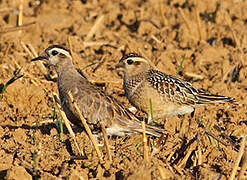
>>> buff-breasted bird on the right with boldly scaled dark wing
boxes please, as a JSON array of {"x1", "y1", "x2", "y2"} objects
[{"x1": 115, "y1": 53, "x2": 235, "y2": 123}]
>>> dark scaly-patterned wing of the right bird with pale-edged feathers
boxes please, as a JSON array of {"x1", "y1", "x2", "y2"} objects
[{"x1": 148, "y1": 70, "x2": 235, "y2": 105}]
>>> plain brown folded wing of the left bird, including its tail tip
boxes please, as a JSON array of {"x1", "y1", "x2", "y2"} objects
[{"x1": 66, "y1": 80, "x2": 164, "y2": 136}]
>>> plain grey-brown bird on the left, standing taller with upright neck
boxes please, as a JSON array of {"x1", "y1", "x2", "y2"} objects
[{"x1": 31, "y1": 45, "x2": 164, "y2": 137}]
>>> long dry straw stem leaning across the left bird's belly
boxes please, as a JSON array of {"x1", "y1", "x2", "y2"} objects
[{"x1": 68, "y1": 92, "x2": 102, "y2": 160}]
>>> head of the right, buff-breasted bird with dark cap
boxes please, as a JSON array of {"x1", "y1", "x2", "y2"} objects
[{"x1": 116, "y1": 53, "x2": 150, "y2": 76}]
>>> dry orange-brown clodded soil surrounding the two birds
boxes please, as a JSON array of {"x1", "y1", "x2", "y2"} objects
[{"x1": 0, "y1": 0, "x2": 247, "y2": 179}]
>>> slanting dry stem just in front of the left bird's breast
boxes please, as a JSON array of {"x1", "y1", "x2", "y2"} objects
[{"x1": 53, "y1": 93, "x2": 84, "y2": 156}]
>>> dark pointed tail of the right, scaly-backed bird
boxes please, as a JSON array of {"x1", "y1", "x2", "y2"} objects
[{"x1": 197, "y1": 93, "x2": 237, "y2": 104}]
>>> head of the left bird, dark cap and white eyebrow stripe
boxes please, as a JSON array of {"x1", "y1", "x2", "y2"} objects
[{"x1": 31, "y1": 45, "x2": 72, "y2": 67}]
